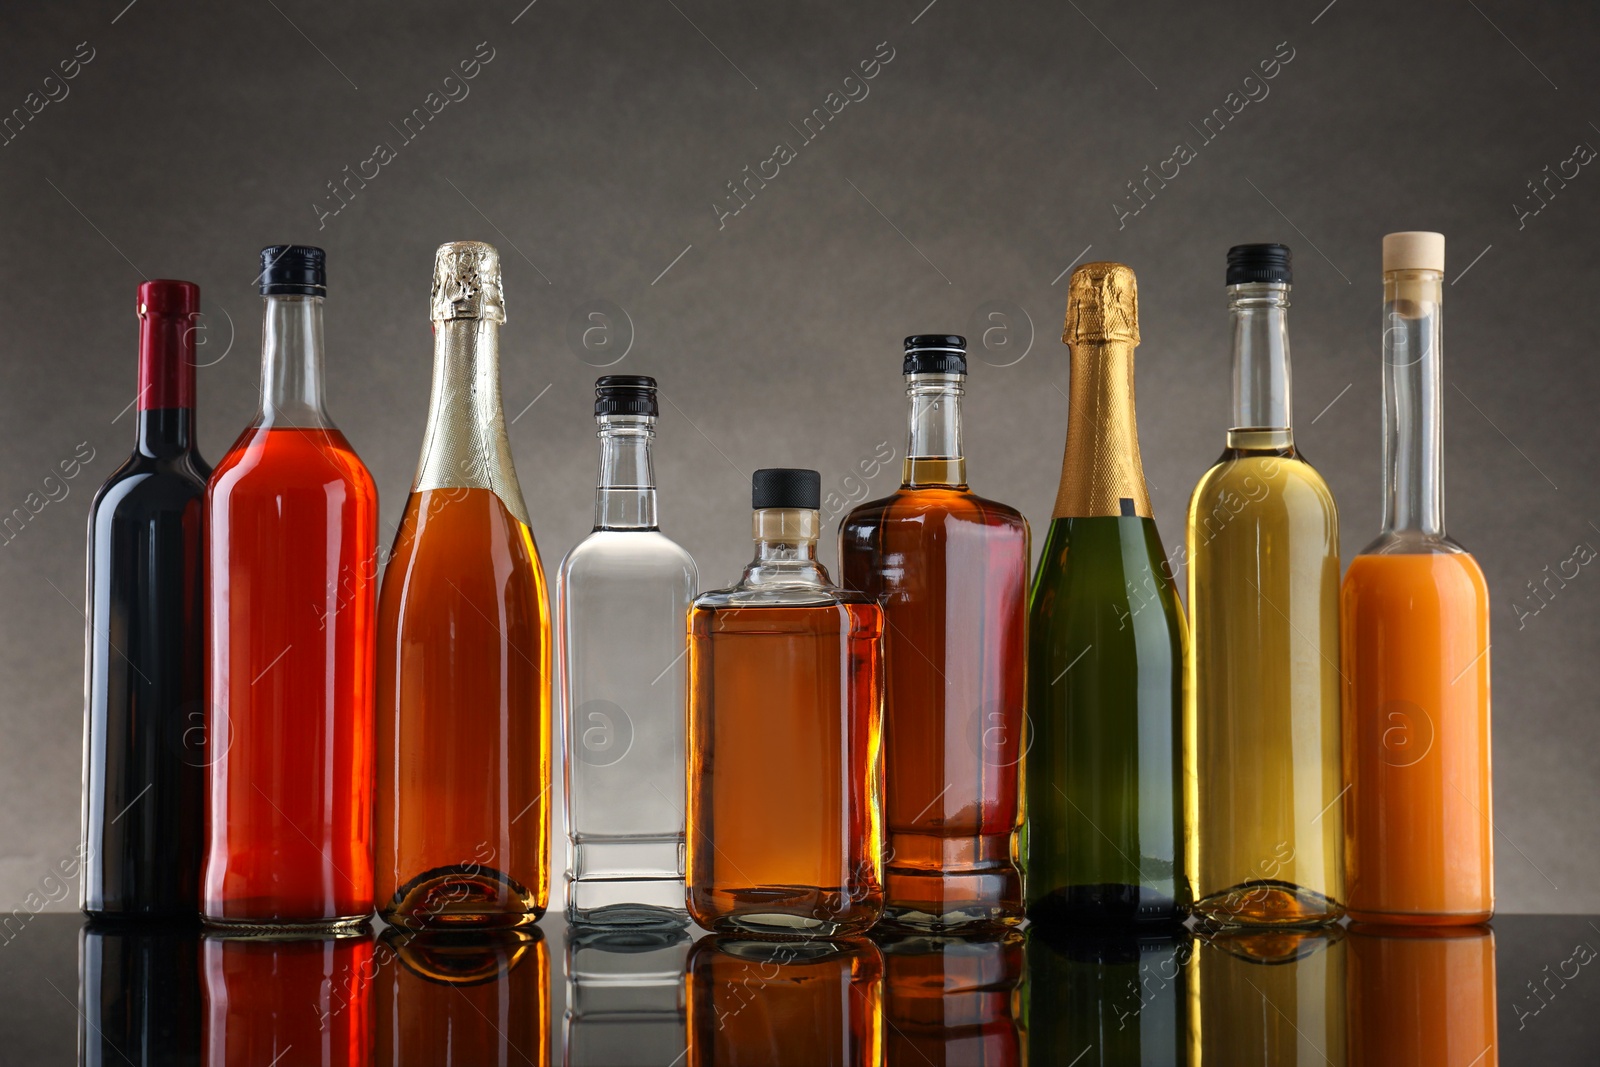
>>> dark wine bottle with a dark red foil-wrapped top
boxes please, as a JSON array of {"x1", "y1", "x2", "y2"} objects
[{"x1": 80, "y1": 282, "x2": 211, "y2": 921}]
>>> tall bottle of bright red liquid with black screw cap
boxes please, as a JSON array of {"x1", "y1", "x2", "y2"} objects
[{"x1": 200, "y1": 245, "x2": 378, "y2": 926}]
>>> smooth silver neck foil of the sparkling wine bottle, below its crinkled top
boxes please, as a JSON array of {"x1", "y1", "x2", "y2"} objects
[{"x1": 413, "y1": 318, "x2": 530, "y2": 526}]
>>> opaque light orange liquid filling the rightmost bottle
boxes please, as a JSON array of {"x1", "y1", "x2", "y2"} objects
[{"x1": 1341, "y1": 553, "x2": 1494, "y2": 925}]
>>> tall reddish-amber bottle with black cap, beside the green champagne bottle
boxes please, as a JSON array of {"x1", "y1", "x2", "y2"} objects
[{"x1": 838, "y1": 334, "x2": 1029, "y2": 929}]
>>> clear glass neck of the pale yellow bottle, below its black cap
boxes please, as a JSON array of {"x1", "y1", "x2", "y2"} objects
[{"x1": 1227, "y1": 282, "x2": 1294, "y2": 448}]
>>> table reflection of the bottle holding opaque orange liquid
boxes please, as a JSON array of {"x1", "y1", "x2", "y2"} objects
[{"x1": 1349, "y1": 926, "x2": 1499, "y2": 1067}]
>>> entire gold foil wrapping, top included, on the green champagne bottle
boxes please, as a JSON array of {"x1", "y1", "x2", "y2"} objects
[{"x1": 1051, "y1": 262, "x2": 1150, "y2": 518}]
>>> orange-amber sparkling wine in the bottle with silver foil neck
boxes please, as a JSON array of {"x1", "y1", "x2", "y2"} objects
[{"x1": 378, "y1": 490, "x2": 550, "y2": 928}]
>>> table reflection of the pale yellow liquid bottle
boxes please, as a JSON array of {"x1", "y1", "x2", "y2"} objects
[{"x1": 1190, "y1": 926, "x2": 1347, "y2": 1067}]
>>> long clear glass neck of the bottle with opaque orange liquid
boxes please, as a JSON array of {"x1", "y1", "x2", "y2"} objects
[{"x1": 1384, "y1": 270, "x2": 1445, "y2": 537}]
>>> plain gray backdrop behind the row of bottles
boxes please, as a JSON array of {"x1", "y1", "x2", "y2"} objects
[{"x1": 0, "y1": 0, "x2": 1600, "y2": 912}]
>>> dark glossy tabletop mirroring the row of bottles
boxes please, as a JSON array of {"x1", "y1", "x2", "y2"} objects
[{"x1": 0, "y1": 913, "x2": 1600, "y2": 1067}]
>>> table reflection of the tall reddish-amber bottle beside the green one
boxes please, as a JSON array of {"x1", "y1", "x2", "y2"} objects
[{"x1": 878, "y1": 929, "x2": 1022, "y2": 1067}]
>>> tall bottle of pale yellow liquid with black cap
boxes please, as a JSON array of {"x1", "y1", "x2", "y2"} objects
[{"x1": 1186, "y1": 245, "x2": 1344, "y2": 926}]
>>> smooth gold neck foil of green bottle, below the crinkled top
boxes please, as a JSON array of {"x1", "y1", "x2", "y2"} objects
[{"x1": 1051, "y1": 339, "x2": 1150, "y2": 518}]
